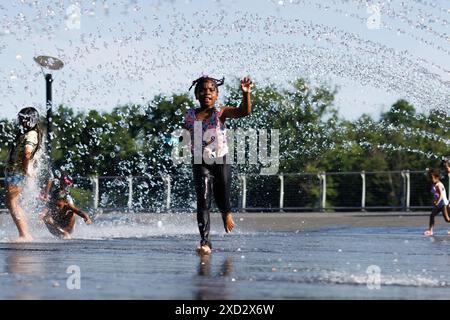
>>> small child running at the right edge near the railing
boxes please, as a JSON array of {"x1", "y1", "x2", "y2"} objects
[{"x1": 424, "y1": 169, "x2": 450, "y2": 236}]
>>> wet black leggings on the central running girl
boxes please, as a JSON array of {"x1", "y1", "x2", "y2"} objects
[{"x1": 193, "y1": 156, "x2": 231, "y2": 248}]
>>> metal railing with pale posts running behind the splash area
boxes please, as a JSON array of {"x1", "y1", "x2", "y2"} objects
[{"x1": 0, "y1": 170, "x2": 450, "y2": 212}]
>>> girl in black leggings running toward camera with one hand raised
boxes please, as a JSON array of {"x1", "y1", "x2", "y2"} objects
[{"x1": 185, "y1": 76, "x2": 252, "y2": 254}]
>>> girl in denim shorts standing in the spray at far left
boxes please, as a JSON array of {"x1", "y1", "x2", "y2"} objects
[{"x1": 5, "y1": 107, "x2": 42, "y2": 242}]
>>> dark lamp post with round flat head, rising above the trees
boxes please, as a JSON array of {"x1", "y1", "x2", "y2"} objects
[{"x1": 34, "y1": 56, "x2": 64, "y2": 163}]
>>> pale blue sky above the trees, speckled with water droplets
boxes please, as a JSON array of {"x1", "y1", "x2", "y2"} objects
[{"x1": 0, "y1": 0, "x2": 450, "y2": 120}]
